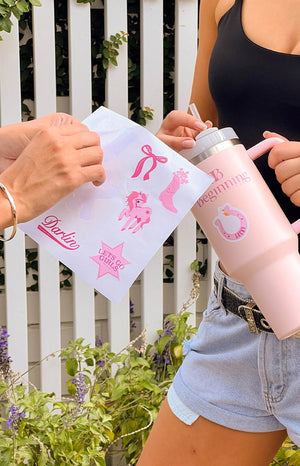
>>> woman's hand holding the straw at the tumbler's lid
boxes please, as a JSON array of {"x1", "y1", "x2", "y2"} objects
[{"x1": 156, "y1": 110, "x2": 212, "y2": 152}]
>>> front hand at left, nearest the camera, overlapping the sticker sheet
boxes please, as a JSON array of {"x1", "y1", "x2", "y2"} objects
[{"x1": 0, "y1": 120, "x2": 105, "y2": 222}]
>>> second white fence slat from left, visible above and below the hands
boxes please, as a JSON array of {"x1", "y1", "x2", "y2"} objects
[{"x1": 32, "y1": 0, "x2": 61, "y2": 398}]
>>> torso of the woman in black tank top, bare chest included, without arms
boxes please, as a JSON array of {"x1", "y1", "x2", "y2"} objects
[{"x1": 209, "y1": 0, "x2": 300, "y2": 237}]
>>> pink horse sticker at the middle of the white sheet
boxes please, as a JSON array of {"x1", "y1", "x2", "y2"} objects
[{"x1": 118, "y1": 191, "x2": 152, "y2": 233}]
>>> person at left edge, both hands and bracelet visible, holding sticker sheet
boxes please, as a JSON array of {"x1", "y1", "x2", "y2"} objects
[{"x1": 0, "y1": 113, "x2": 105, "y2": 240}]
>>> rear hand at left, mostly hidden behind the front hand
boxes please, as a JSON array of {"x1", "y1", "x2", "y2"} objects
[{"x1": 0, "y1": 113, "x2": 81, "y2": 173}]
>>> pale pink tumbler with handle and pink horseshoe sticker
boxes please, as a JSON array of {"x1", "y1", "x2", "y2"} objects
[{"x1": 181, "y1": 128, "x2": 300, "y2": 339}]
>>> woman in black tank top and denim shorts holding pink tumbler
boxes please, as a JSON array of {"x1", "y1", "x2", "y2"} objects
[{"x1": 138, "y1": 0, "x2": 300, "y2": 466}]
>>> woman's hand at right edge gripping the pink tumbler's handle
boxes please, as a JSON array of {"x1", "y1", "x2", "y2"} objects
[{"x1": 264, "y1": 131, "x2": 300, "y2": 207}]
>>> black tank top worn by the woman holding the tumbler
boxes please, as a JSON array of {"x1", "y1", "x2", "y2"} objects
[{"x1": 209, "y1": 0, "x2": 300, "y2": 248}]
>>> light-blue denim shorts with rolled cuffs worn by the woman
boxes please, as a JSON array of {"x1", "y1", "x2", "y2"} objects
[{"x1": 168, "y1": 265, "x2": 300, "y2": 447}]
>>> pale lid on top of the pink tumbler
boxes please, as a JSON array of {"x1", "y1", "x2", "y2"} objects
[{"x1": 180, "y1": 127, "x2": 238, "y2": 160}]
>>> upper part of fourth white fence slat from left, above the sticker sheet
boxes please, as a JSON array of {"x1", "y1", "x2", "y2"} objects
[{"x1": 104, "y1": 0, "x2": 128, "y2": 117}]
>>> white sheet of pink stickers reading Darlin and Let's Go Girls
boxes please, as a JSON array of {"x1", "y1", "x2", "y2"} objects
[{"x1": 19, "y1": 107, "x2": 213, "y2": 303}]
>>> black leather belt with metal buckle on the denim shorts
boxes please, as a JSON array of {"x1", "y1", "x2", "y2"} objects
[{"x1": 214, "y1": 279, "x2": 274, "y2": 334}]
